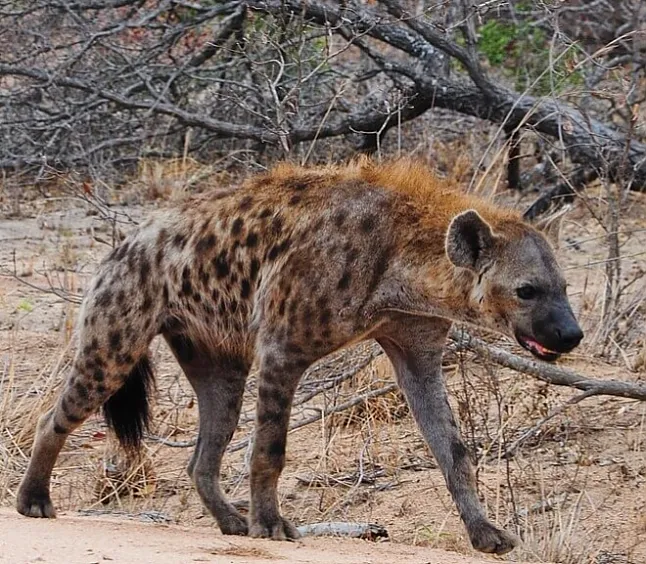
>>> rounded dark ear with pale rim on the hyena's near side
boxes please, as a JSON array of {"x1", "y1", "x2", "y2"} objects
[{"x1": 446, "y1": 210, "x2": 495, "y2": 271}]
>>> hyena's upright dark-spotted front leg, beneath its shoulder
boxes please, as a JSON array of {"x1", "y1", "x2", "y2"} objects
[{"x1": 249, "y1": 346, "x2": 310, "y2": 540}]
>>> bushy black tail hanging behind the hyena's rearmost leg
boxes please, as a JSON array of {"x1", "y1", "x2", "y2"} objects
[{"x1": 103, "y1": 355, "x2": 155, "y2": 452}]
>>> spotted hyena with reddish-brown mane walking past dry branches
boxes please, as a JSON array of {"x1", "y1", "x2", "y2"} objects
[{"x1": 17, "y1": 161, "x2": 583, "y2": 554}]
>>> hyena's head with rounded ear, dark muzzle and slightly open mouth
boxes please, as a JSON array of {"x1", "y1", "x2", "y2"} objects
[{"x1": 446, "y1": 210, "x2": 583, "y2": 360}]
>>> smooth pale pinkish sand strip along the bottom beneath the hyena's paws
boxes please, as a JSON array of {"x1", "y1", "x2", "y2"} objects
[{"x1": 0, "y1": 509, "x2": 512, "y2": 564}]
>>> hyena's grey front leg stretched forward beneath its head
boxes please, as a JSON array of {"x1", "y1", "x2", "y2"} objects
[{"x1": 378, "y1": 319, "x2": 516, "y2": 554}]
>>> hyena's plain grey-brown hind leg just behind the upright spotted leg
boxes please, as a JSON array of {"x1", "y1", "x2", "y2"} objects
[{"x1": 165, "y1": 335, "x2": 249, "y2": 535}]
